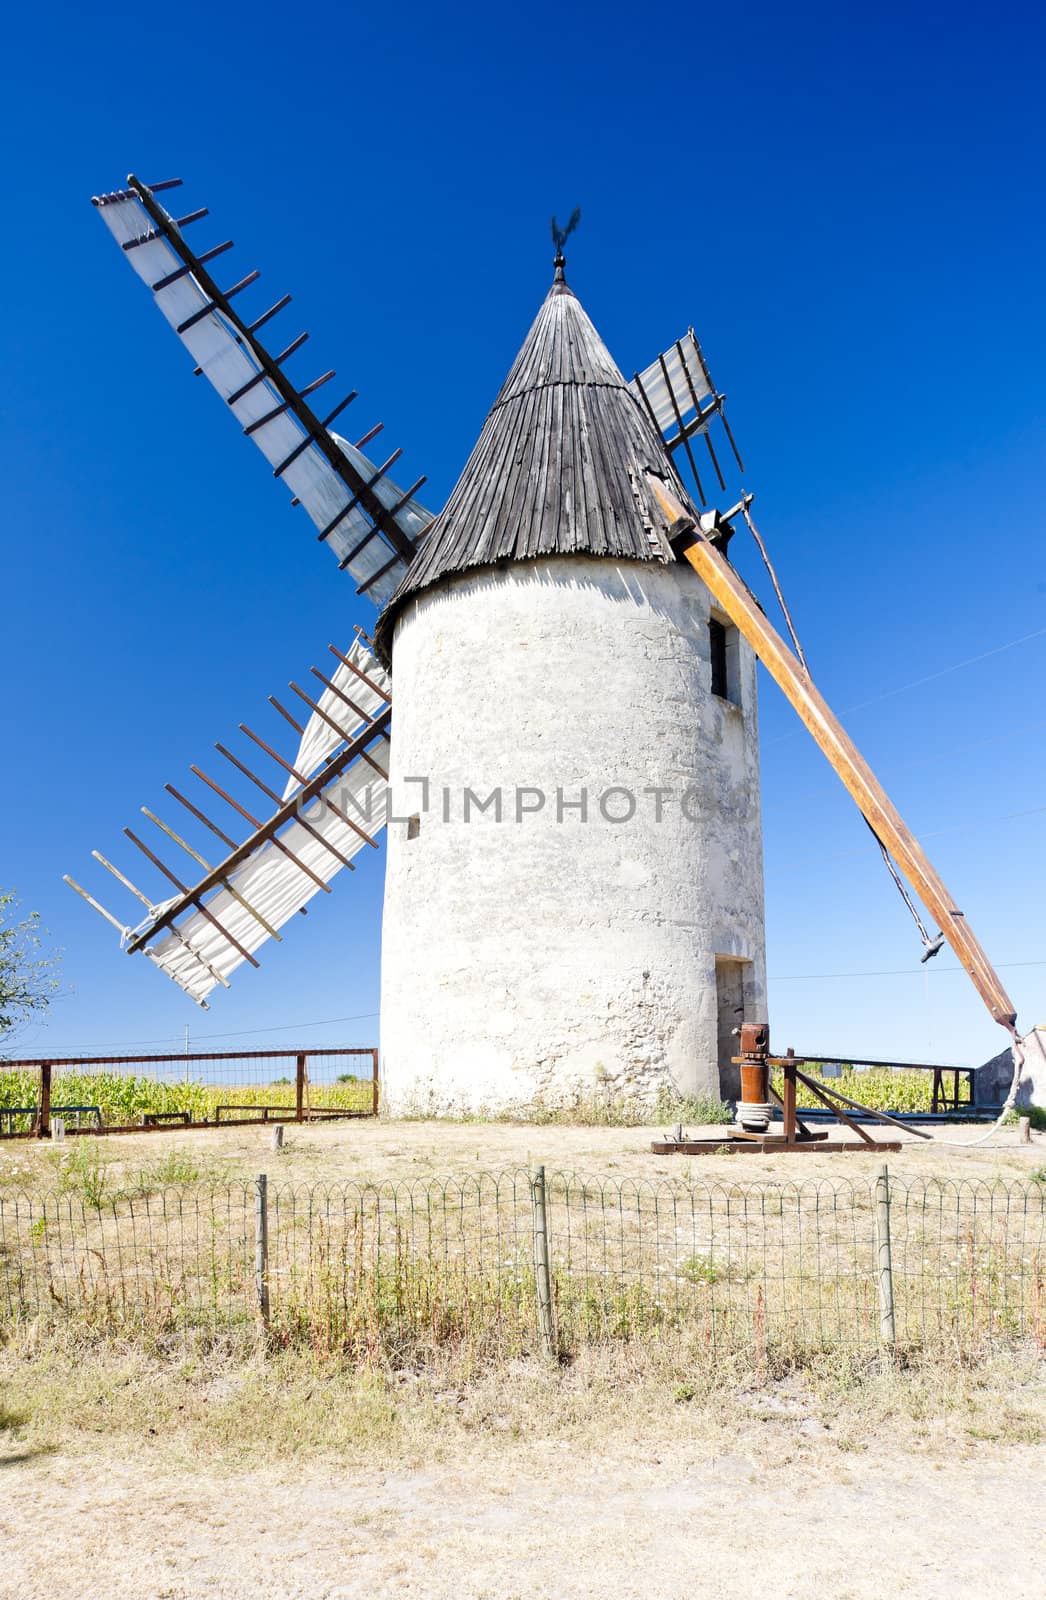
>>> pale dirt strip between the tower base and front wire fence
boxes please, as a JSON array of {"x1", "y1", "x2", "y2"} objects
[{"x1": 0, "y1": 1118, "x2": 1046, "y2": 1194}]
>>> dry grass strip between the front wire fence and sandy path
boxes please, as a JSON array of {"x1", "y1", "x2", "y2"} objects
[{"x1": 0, "y1": 1336, "x2": 1046, "y2": 1474}]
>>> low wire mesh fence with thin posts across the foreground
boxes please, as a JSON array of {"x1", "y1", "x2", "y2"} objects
[{"x1": 0, "y1": 1170, "x2": 1046, "y2": 1362}]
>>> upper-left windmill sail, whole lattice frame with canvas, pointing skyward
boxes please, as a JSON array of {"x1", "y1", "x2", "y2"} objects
[{"x1": 94, "y1": 176, "x2": 432, "y2": 606}]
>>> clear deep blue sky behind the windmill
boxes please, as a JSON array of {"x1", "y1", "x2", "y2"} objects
[{"x1": 0, "y1": 3, "x2": 1046, "y2": 1061}]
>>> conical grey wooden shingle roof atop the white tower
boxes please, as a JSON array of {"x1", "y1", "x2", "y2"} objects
[{"x1": 376, "y1": 259, "x2": 675, "y2": 658}]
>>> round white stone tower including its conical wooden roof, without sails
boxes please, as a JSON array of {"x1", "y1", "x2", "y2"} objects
[{"x1": 377, "y1": 258, "x2": 766, "y2": 1114}]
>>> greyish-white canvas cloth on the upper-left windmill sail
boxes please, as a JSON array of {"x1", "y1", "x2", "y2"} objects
[{"x1": 99, "y1": 195, "x2": 432, "y2": 605}]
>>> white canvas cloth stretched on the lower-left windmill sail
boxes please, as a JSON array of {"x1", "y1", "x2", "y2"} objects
[{"x1": 131, "y1": 640, "x2": 390, "y2": 1005}]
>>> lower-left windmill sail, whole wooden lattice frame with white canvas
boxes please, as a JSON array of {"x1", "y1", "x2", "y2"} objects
[{"x1": 66, "y1": 638, "x2": 392, "y2": 1005}]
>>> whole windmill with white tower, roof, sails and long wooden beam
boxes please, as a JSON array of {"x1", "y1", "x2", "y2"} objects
[{"x1": 67, "y1": 178, "x2": 1014, "y2": 1110}]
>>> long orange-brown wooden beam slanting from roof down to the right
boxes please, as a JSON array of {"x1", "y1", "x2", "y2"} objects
[{"x1": 646, "y1": 472, "x2": 1017, "y2": 1032}]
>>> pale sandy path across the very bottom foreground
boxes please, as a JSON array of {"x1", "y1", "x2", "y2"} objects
[{"x1": 0, "y1": 1440, "x2": 1046, "y2": 1600}]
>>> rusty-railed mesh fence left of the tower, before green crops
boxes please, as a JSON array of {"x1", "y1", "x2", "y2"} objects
[{"x1": 0, "y1": 1045, "x2": 377, "y2": 1138}]
